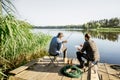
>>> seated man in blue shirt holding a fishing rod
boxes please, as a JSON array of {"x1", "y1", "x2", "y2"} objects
[{"x1": 49, "y1": 32, "x2": 67, "y2": 56}]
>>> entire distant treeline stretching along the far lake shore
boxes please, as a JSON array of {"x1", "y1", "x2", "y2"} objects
[{"x1": 33, "y1": 17, "x2": 120, "y2": 29}]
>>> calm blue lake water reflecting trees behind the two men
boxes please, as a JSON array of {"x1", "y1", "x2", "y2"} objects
[{"x1": 32, "y1": 29, "x2": 120, "y2": 64}]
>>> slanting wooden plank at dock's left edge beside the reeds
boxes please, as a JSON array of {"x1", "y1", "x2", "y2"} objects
[{"x1": 9, "y1": 60, "x2": 36, "y2": 74}]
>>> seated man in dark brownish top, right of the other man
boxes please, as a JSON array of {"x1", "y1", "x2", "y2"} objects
[{"x1": 76, "y1": 34, "x2": 100, "y2": 68}]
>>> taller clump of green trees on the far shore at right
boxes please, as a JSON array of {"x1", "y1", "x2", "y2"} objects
[{"x1": 83, "y1": 18, "x2": 120, "y2": 29}]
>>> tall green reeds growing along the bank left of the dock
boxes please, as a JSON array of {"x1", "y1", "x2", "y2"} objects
[{"x1": 0, "y1": 15, "x2": 51, "y2": 80}]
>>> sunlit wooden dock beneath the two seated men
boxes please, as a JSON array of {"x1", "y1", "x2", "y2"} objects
[{"x1": 9, "y1": 56, "x2": 120, "y2": 80}]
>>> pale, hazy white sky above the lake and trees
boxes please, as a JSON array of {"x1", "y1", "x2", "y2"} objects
[{"x1": 13, "y1": 0, "x2": 120, "y2": 26}]
